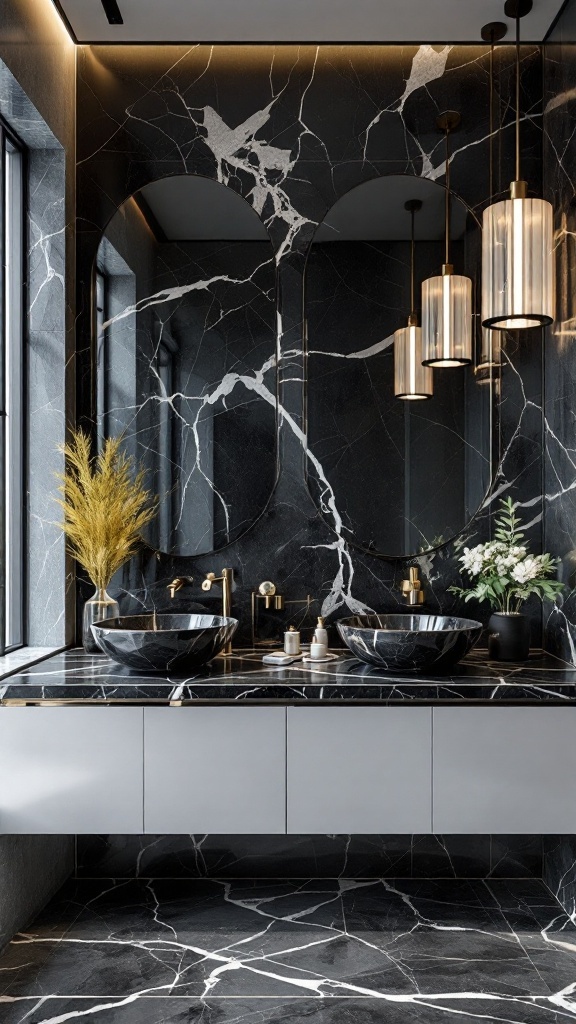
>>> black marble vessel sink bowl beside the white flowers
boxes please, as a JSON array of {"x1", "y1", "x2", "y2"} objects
[{"x1": 336, "y1": 613, "x2": 483, "y2": 673}]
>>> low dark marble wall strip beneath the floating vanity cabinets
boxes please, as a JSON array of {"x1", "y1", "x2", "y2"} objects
[{"x1": 76, "y1": 835, "x2": 541, "y2": 879}]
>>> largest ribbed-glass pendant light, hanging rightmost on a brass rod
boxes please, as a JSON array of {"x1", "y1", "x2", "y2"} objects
[{"x1": 482, "y1": 0, "x2": 554, "y2": 331}]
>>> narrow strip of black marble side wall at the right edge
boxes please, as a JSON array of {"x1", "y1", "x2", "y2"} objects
[{"x1": 543, "y1": 0, "x2": 576, "y2": 663}]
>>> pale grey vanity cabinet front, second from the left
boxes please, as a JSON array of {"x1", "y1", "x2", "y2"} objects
[{"x1": 145, "y1": 707, "x2": 286, "y2": 835}]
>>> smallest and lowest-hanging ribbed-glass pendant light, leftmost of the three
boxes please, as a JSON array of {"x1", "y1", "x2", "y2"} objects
[{"x1": 394, "y1": 199, "x2": 434, "y2": 401}]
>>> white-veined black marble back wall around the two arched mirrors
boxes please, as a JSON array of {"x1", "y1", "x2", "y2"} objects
[{"x1": 77, "y1": 45, "x2": 542, "y2": 642}]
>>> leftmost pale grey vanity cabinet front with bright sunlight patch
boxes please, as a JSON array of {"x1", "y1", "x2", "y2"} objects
[{"x1": 0, "y1": 707, "x2": 143, "y2": 835}]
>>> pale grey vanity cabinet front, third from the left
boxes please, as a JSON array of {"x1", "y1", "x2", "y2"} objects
[{"x1": 287, "y1": 706, "x2": 431, "y2": 834}]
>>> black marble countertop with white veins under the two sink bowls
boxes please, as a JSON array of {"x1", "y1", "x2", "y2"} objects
[{"x1": 0, "y1": 648, "x2": 576, "y2": 707}]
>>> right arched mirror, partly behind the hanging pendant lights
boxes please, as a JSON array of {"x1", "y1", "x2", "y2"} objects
[{"x1": 304, "y1": 175, "x2": 498, "y2": 557}]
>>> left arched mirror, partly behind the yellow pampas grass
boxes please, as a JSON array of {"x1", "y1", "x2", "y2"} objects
[{"x1": 95, "y1": 175, "x2": 277, "y2": 555}]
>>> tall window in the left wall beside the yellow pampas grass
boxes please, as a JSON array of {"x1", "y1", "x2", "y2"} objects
[{"x1": 0, "y1": 122, "x2": 26, "y2": 654}]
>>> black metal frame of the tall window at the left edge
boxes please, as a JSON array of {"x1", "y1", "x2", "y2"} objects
[{"x1": 0, "y1": 117, "x2": 29, "y2": 655}]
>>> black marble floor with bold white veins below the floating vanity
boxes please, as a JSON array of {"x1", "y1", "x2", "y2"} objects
[{"x1": 0, "y1": 879, "x2": 576, "y2": 1024}]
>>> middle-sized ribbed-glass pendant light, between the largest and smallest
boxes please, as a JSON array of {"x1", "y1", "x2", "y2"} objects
[{"x1": 422, "y1": 111, "x2": 472, "y2": 367}]
